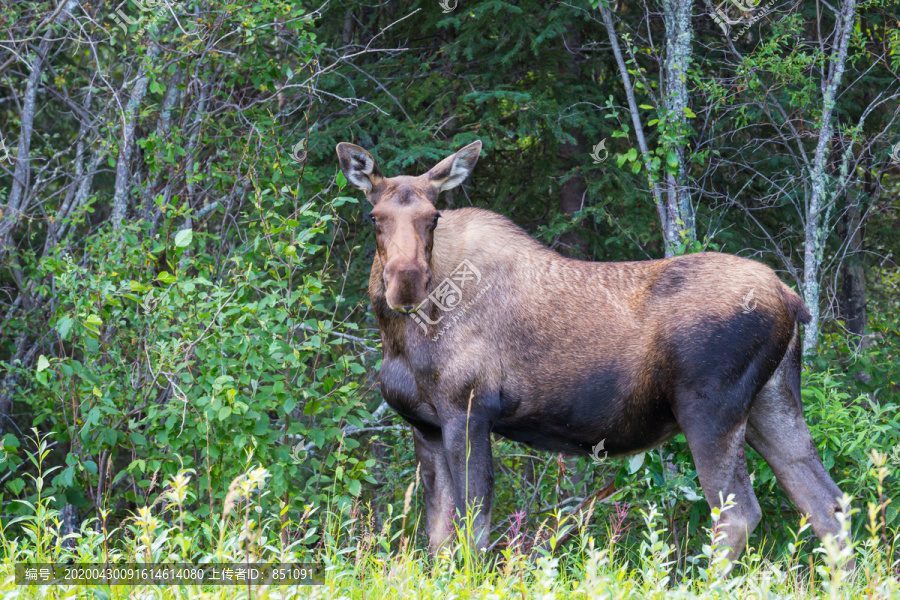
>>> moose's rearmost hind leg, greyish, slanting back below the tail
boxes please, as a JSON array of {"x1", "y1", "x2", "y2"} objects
[{"x1": 747, "y1": 351, "x2": 842, "y2": 539}]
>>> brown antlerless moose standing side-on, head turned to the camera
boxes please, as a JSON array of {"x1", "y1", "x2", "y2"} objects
[{"x1": 337, "y1": 141, "x2": 842, "y2": 560}]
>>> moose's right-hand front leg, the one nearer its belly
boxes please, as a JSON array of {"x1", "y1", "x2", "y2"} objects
[{"x1": 442, "y1": 413, "x2": 494, "y2": 550}]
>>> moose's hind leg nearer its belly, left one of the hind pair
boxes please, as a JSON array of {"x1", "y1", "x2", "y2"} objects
[{"x1": 677, "y1": 399, "x2": 762, "y2": 571}]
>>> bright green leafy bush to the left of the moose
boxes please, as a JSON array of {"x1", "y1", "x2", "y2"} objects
[{"x1": 0, "y1": 189, "x2": 375, "y2": 518}]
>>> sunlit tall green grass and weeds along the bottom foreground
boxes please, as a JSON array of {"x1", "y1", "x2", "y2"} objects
[{"x1": 0, "y1": 438, "x2": 900, "y2": 600}]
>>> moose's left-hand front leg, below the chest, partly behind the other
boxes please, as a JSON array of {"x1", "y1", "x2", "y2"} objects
[{"x1": 413, "y1": 427, "x2": 453, "y2": 556}]
